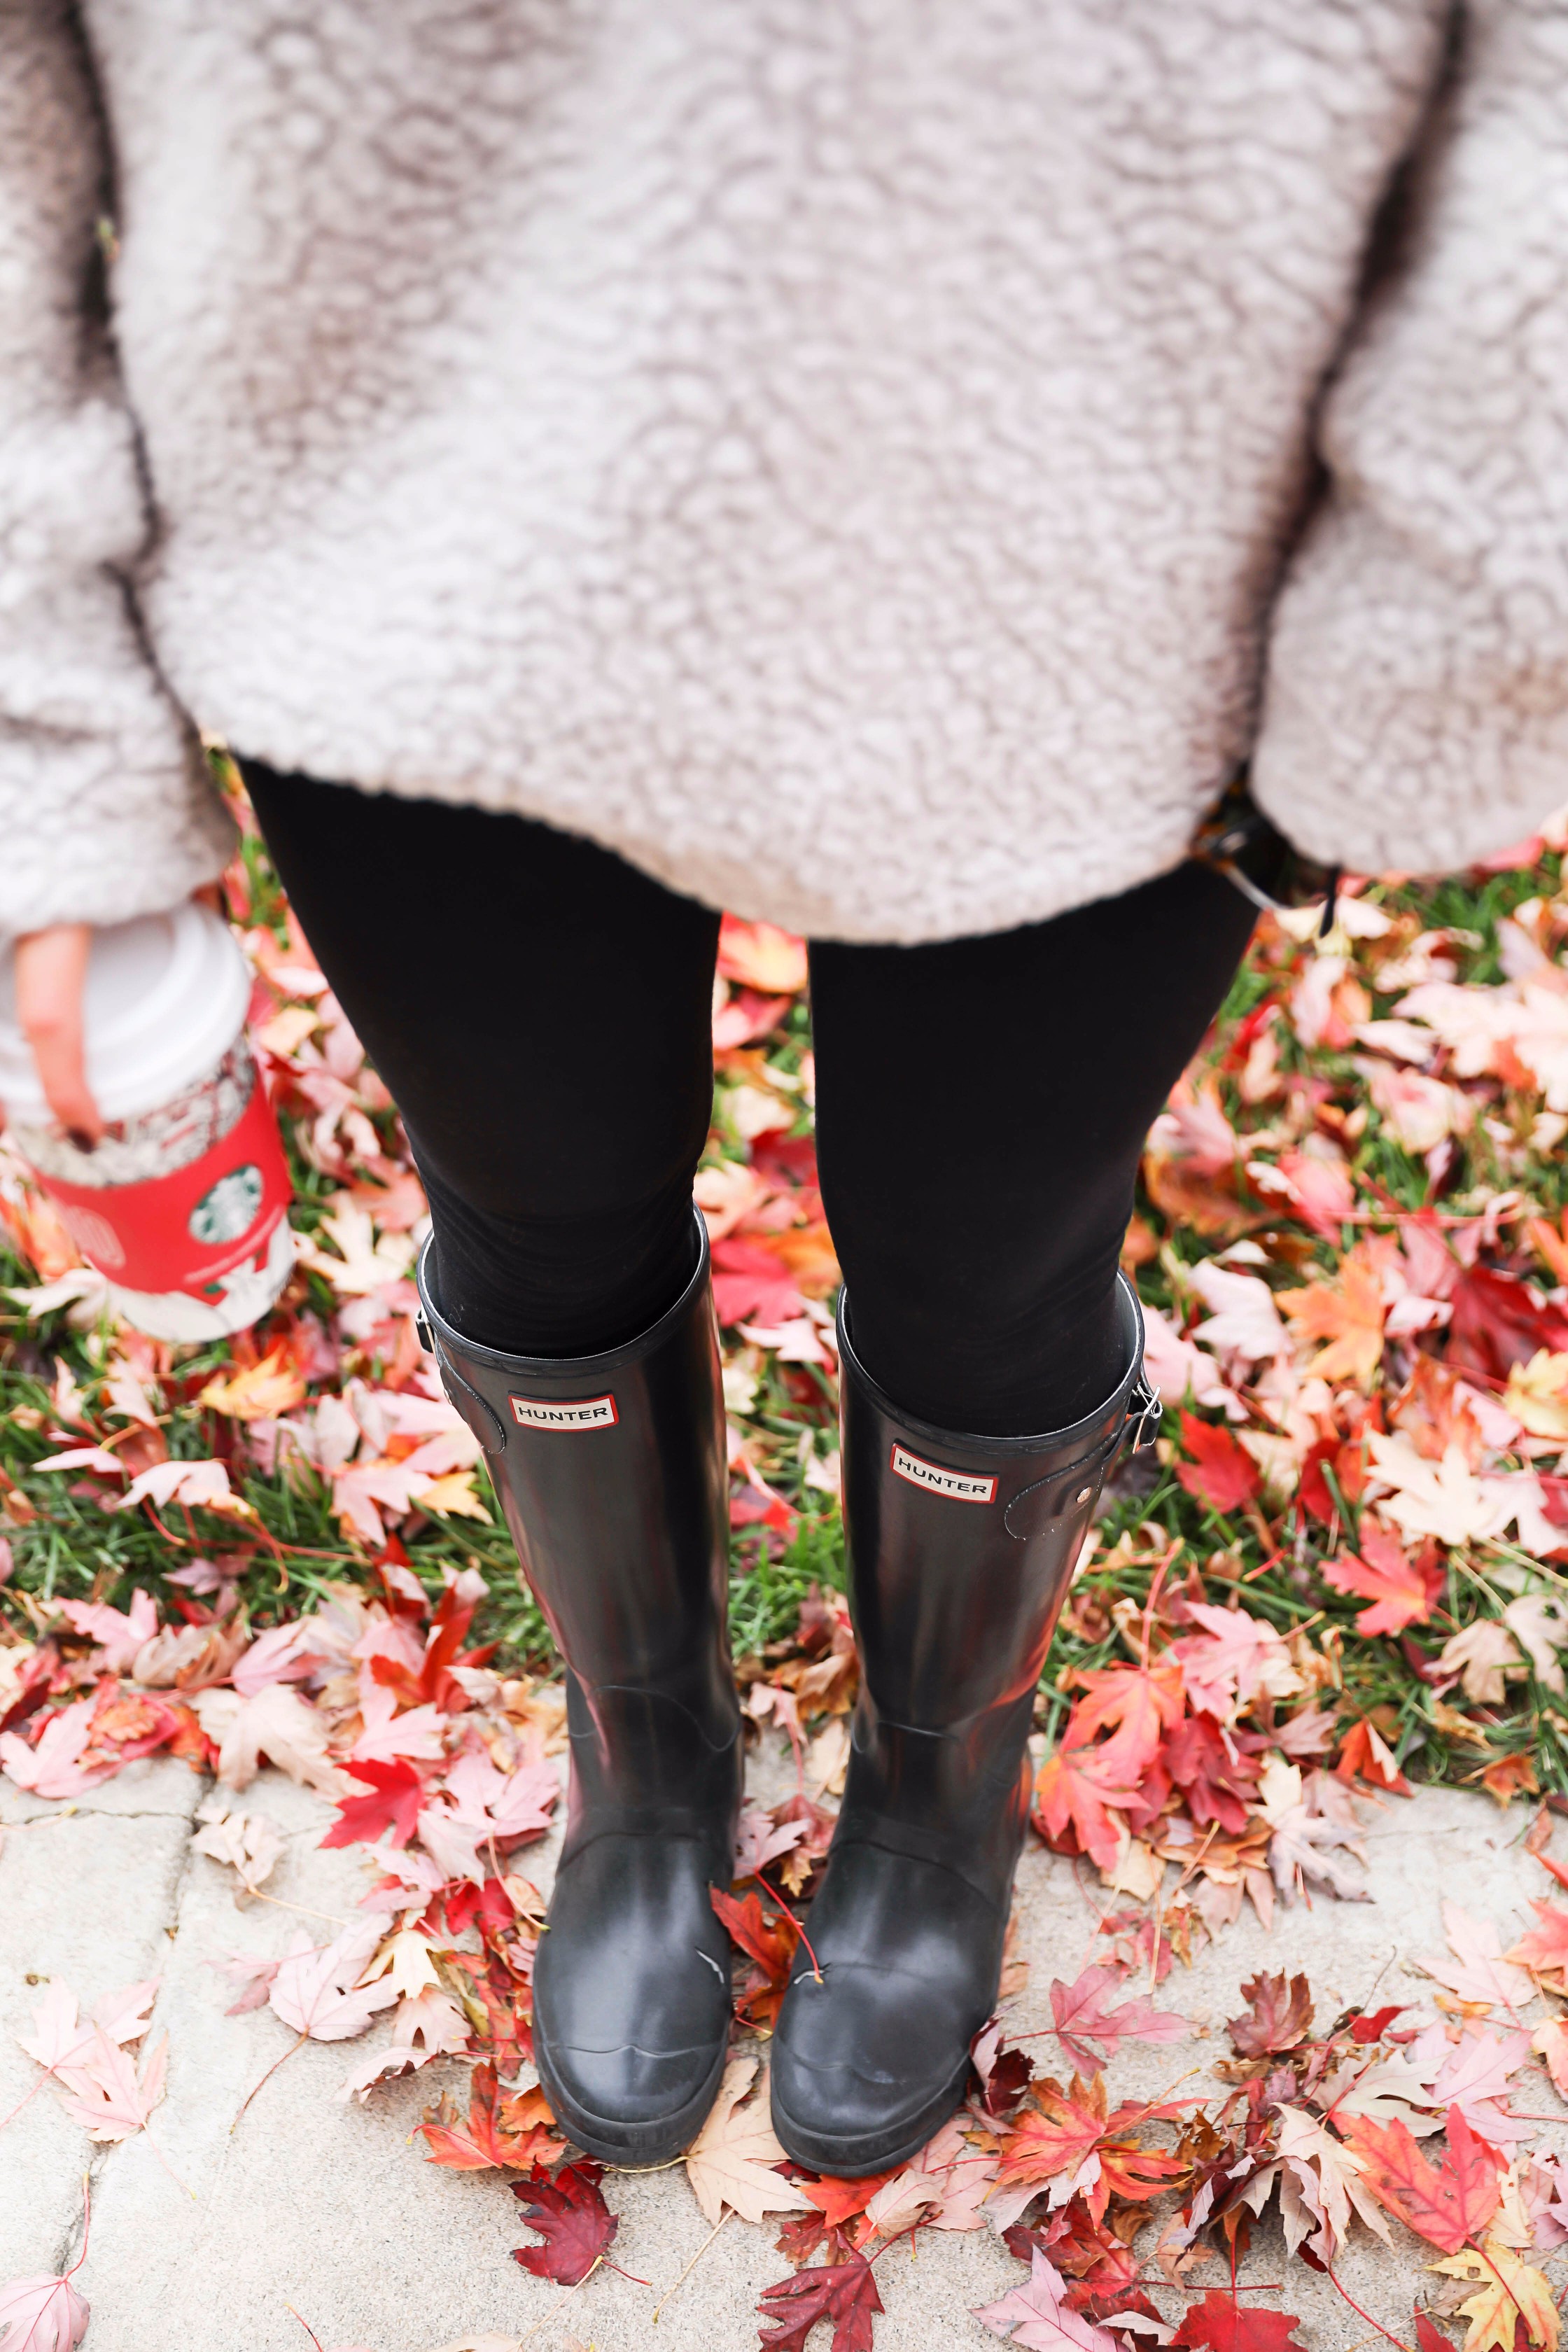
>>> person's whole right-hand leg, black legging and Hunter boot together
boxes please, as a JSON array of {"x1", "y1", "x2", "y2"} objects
[{"x1": 774, "y1": 868, "x2": 1253, "y2": 2174}]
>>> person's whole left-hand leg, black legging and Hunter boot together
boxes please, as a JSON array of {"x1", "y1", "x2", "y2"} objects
[{"x1": 249, "y1": 769, "x2": 741, "y2": 2164}]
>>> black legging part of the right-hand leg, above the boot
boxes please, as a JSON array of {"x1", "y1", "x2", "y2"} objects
[{"x1": 811, "y1": 863, "x2": 1255, "y2": 1435}]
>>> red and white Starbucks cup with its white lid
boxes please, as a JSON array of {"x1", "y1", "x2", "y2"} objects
[{"x1": 0, "y1": 903, "x2": 294, "y2": 1340}]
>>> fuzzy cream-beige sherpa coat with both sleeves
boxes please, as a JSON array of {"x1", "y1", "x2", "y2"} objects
[{"x1": 0, "y1": 0, "x2": 1568, "y2": 941}]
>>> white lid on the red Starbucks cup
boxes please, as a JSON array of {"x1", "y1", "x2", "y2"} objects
[{"x1": 0, "y1": 901, "x2": 249, "y2": 1126}]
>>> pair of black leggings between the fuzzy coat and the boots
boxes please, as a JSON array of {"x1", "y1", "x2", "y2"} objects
[{"x1": 244, "y1": 762, "x2": 1253, "y2": 1435}]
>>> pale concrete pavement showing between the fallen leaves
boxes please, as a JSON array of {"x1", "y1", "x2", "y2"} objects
[{"x1": 0, "y1": 1755, "x2": 1568, "y2": 2352}]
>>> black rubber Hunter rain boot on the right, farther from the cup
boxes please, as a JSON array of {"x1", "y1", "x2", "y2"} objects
[{"x1": 774, "y1": 1280, "x2": 1159, "y2": 2178}]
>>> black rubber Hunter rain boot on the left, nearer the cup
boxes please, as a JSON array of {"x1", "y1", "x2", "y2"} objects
[{"x1": 419, "y1": 1216, "x2": 743, "y2": 2166}]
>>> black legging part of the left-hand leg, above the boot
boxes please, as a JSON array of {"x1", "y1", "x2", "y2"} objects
[{"x1": 244, "y1": 760, "x2": 720, "y2": 1354}]
